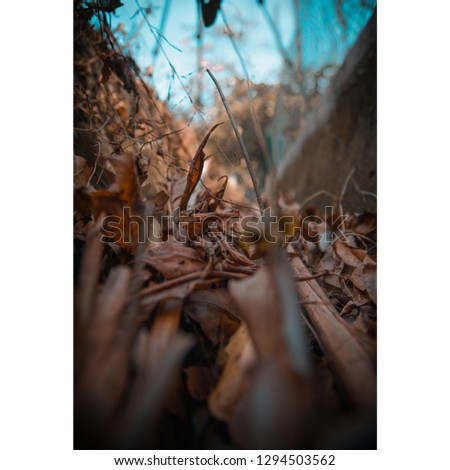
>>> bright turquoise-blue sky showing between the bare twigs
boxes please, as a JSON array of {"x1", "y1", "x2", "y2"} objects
[{"x1": 103, "y1": 0, "x2": 376, "y2": 117}]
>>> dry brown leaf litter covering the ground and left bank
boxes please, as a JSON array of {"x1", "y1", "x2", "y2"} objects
[{"x1": 74, "y1": 3, "x2": 376, "y2": 449}]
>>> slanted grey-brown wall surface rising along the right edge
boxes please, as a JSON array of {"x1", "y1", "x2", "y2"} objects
[{"x1": 280, "y1": 11, "x2": 377, "y2": 212}]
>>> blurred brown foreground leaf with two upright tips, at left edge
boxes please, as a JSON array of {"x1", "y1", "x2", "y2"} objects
[{"x1": 74, "y1": 250, "x2": 131, "y2": 446}]
